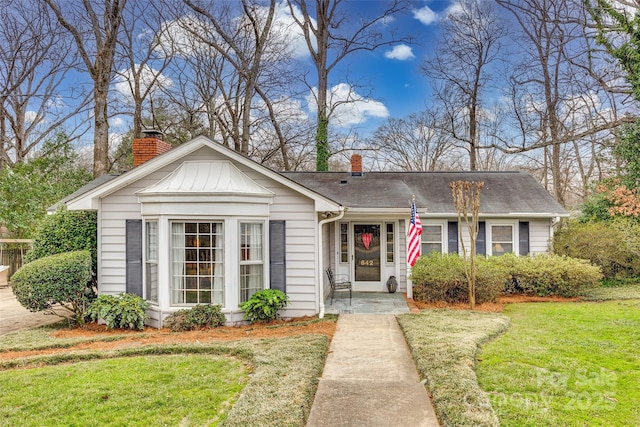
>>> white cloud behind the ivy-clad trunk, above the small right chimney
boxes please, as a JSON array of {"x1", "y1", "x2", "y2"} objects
[{"x1": 307, "y1": 83, "x2": 389, "y2": 127}]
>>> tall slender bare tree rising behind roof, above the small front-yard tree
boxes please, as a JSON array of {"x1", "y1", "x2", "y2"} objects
[{"x1": 422, "y1": 0, "x2": 507, "y2": 170}]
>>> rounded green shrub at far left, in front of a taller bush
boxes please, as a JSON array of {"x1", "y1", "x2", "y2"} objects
[{"x1": 11, "y1": 251, "x2": 94, "y2": 323}]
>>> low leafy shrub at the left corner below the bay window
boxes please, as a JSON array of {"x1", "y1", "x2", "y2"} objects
[{"x1": 87, "y1": 294, "x2": 149, "y2": 330}]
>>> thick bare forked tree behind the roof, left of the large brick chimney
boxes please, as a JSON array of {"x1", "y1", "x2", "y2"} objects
[{"x1": 41, "y1": 0, "x2": 127, "y2": 177}]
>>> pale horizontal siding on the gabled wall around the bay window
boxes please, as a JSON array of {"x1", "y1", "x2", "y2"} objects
[{"x1": 98, "y1": 148, "x2": 318, "y2": 317}]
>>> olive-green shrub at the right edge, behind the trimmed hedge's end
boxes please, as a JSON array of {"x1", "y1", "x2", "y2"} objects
[{"x1": 553, "y1": 218, "x2": 640, "y2": 279}]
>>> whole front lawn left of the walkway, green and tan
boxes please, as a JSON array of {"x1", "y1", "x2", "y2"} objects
[{"x1": 0, "y1": 318, "x2": 336, "y2": 426}]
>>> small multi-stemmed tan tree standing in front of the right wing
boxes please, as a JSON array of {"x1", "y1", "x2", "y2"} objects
[{"x1": 449, "y1": 181, "x2": 484, "y2": 310}]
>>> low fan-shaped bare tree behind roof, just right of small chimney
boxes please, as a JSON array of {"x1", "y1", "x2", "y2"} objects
[{"x1": 370, "y1": 110, "x2": 456, "y2": 171}]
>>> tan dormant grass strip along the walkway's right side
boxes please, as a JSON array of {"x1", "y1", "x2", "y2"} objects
[{"x1": 398, "y1": 309, "x2": 509, "y2": 427}]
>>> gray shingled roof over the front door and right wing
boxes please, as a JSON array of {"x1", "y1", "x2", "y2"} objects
[{"x1": 282, "y1": 172, "x2": 567, "y2": 216}]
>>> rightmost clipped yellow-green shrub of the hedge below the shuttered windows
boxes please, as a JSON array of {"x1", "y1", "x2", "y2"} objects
[{"x1": 494, "y1": 254, "x2": 602, "y2": 297}]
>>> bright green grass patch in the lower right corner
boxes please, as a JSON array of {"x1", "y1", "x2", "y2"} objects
[{"x1": 477, "y1": 301, "x2": 640, "y2": 427}]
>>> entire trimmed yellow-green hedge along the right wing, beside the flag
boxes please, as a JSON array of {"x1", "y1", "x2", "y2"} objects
[{"x1": 411, "y1": 253, "x2": 602, "y2": 304}]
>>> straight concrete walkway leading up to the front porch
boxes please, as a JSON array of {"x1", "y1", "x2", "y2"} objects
[{"x1": 307, "y1": 314, "x2": 440, "y2": 427}]
